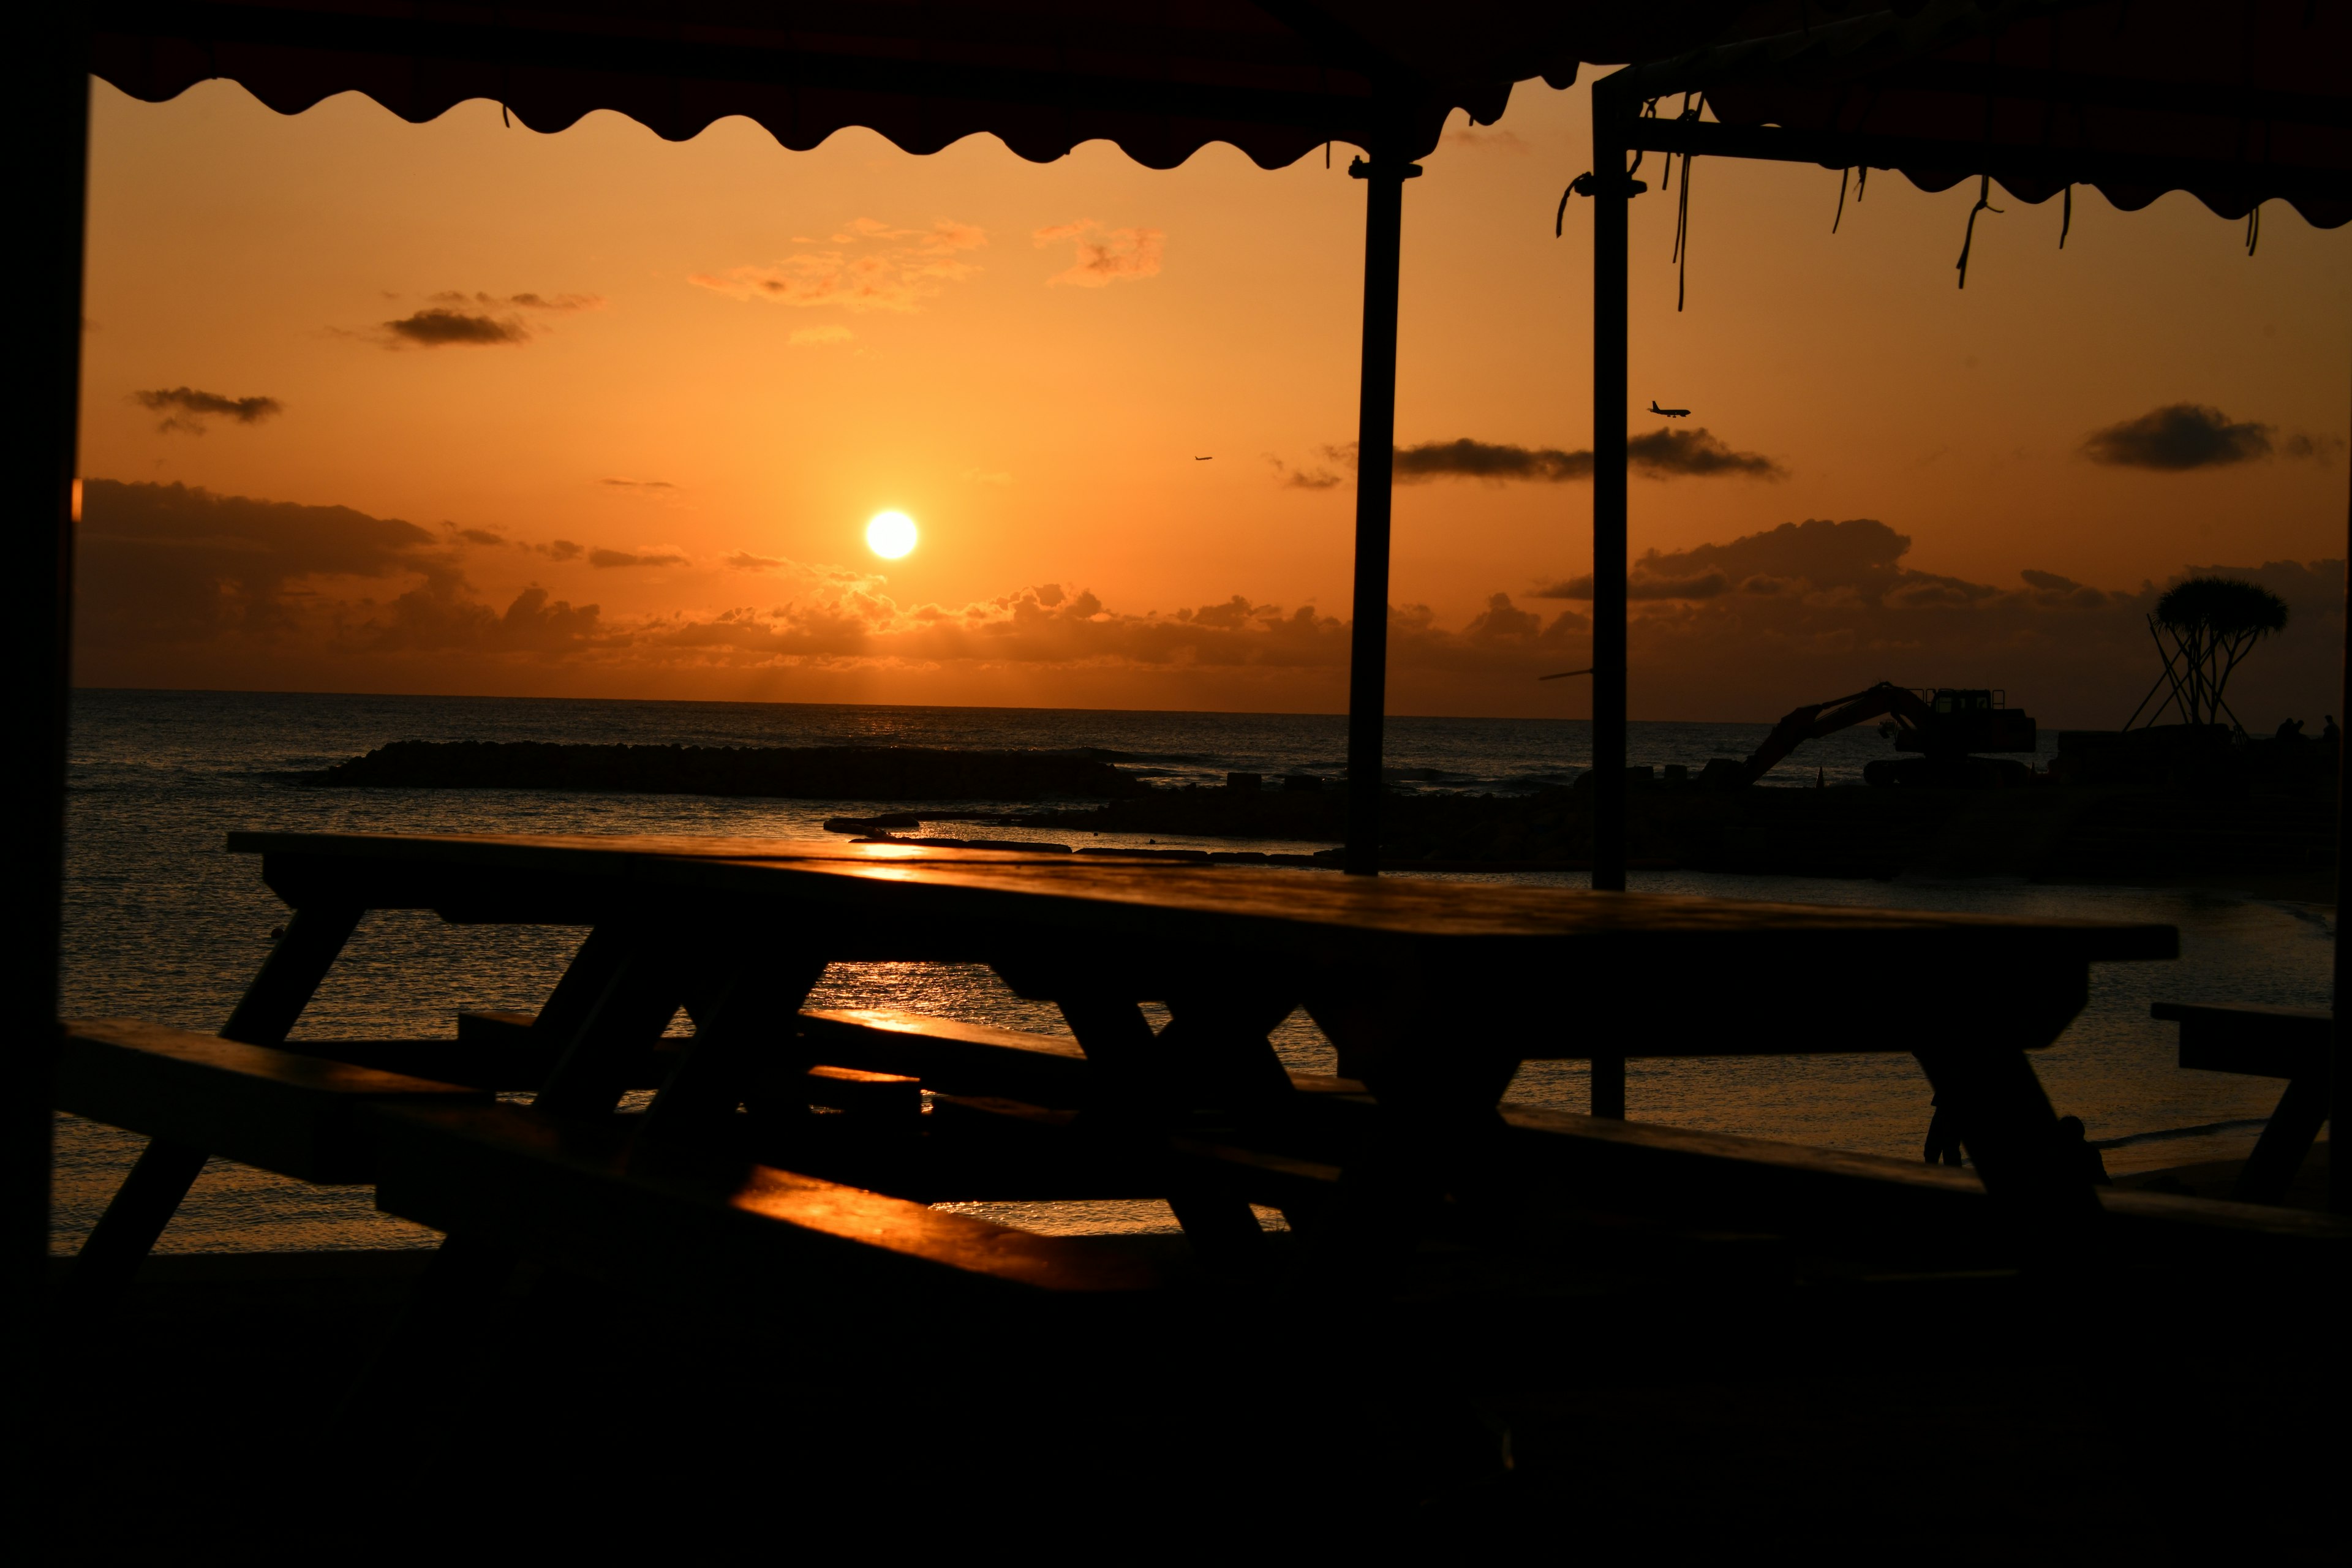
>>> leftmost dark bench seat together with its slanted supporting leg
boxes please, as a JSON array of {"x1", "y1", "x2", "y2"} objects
[{"x1": 56, "y1": 1018, "x2": 489, "y2": 1314}]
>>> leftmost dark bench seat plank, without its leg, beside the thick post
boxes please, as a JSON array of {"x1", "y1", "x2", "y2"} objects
[{"x1": 56, "y1": 1018, "x2": 489, "y2": 1183}]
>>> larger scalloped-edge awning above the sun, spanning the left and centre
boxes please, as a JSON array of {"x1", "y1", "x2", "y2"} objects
[{"x1": 92, "y1": 0, "x2": 1743, "y2": 169}]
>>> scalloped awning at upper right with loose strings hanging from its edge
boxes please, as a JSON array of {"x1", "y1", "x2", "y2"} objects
[{"x1": 1609, "y1": 0, "x2": 2352, "y2": 228}]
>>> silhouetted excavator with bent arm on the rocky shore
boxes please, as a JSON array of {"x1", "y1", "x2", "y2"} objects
[{"x1": 1708, "y1": 682, "x2": 2037, "y2": 790}]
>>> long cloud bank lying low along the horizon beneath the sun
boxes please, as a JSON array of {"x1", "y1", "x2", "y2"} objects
[{"x1": 75, "y1": 480, "x2": 2343, "y2": 728}]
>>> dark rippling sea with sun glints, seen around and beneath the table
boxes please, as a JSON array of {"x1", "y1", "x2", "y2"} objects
[{"x1": 51, "y1": 691, "x2": 2335, "y2": 1253}]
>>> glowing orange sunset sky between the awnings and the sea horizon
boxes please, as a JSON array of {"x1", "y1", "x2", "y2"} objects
[{"x1": 80, "y1": 67, "x2": 2352, "y2": 724}]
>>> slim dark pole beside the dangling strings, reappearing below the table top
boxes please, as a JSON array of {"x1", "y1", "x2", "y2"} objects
[{"x1": 1593, "y1": 80, "x2": 1632, "y2": 1117}]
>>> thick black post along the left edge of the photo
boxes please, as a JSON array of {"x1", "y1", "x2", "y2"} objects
[{"x1": 0, "y1": 5, "x2": 89, "y2": 1523}]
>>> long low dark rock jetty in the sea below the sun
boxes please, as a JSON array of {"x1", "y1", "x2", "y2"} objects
[{"x1": 303, "y1": 741, "x2": 1145, "y2": 802}]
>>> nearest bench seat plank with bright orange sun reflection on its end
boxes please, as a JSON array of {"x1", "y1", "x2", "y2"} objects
[{"x1": 376, "y1": 1105, "x2": 1162, "y2": 1310}]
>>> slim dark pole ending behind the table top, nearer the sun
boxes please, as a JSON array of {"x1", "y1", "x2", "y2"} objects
[{"x1": 1345, "y1": 151, "x2": 1420, "y2": 877}]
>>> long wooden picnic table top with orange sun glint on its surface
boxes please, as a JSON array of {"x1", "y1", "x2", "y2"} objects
[{"x1": 228, "y1": 832, "x2": 2180, "y2": 968}]
